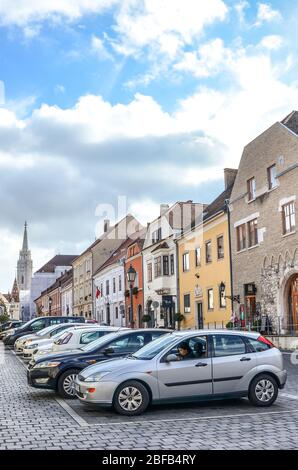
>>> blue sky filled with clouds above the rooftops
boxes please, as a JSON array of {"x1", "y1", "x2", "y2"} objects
[{"x1": 0, "y1": 0, "x2": 298, "y2": 292}]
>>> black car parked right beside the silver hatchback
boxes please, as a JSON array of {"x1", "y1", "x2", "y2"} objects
[{"x1": 27, "y1": 328, "x2": 169, "y2": 398}]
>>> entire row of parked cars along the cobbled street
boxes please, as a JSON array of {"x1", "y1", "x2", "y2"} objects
[{"x1": 4, "y1": 317, "x2": 287, "y2": 415}]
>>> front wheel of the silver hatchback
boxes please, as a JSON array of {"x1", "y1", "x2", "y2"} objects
[{"x1": 113, "y1": 380, "x2": 150, "y2": 416}]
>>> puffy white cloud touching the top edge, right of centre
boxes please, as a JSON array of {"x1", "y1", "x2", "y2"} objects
[{"x1": 114, "y1": 0, "x2": 228, "y2": 58}]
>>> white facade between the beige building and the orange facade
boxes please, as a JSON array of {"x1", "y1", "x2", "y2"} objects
[{"x1": 94, "y1": 261, "x2": 125, "y2": 327}]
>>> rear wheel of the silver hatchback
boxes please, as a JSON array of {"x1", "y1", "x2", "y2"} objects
[{"x1": 248, "y1": 374, "x2": 278, "y2": 406}]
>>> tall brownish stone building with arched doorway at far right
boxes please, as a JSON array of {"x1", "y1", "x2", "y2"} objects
[{"x1": 230, "y1": 111, "x2": 298, "y2": 333}]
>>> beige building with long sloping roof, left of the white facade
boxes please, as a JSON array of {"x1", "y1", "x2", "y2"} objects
[{"x1": 72, "y1": 214, "x2": 140, "y2": 318}]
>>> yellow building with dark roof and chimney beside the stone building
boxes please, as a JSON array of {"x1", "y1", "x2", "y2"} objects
[{"x1": 177, "y1": 169, "x2": 236, "y2": 329}]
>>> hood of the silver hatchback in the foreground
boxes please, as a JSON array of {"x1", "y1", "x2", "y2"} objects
[{"x1": 80, "y1": 357, "x2": 152, "y2": 378}]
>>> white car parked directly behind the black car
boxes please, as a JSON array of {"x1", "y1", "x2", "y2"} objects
[{"x1": 23, "y1": 324, "x2": 124, "y2": 360}]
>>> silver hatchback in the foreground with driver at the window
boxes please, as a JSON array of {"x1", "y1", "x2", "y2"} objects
[{"x1": 75, "y1": 330, "x2": 287, "y2": 415}]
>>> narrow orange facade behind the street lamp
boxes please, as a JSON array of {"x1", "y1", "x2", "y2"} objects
[{"x1": 125, "y1": 238, "x2": 144, "y2": 328}]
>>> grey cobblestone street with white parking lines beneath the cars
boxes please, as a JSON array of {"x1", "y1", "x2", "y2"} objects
[{"x1": 0, "y1": 344, "x2": 298, "y2": 450}]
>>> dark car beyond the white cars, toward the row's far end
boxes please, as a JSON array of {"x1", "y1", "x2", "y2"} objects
[{"x1": 3, "y1": 316, "x2": 85, "y2": 346}]
